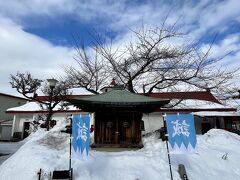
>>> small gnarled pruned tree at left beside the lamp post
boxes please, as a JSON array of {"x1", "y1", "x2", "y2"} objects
[{"x1": 10, "y1": 72, "x2": 70, "y2": 130}]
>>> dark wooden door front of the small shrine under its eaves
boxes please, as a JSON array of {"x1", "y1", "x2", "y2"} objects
[{"x1": 94, "y1": 112, "x2": 142, "y2": 146}]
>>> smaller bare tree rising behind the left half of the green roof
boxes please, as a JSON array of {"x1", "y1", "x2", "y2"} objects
[{"x1": 64, "y1": 37, "x2": 110, "y2": 94}]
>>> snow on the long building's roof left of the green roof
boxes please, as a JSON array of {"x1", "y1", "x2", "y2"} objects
[{"x1": 7, "y1": 102, "x2": 79, "y2": 112}]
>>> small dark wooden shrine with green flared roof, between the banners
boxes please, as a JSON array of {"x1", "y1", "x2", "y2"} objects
[{"x1": 67, "y1": 87, "x2": 170, "y2": 147}]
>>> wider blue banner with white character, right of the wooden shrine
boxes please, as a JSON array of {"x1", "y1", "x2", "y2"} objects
[{"x1": 166, "y1": 114, "x2": 197, "y2": 150}]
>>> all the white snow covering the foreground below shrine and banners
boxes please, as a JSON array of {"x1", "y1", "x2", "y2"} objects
[{"x1": 0, "y1": 120, "x2": 240, "y2": 180}]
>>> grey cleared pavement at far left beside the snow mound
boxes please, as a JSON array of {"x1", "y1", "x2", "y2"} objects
[{"x1": 0, "y1": 142, "x2": 24, "y2": 165}]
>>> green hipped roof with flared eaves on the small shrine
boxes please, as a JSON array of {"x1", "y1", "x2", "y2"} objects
[{"x1": 67, "y1": 88, "x2": 169, "y2": 112}]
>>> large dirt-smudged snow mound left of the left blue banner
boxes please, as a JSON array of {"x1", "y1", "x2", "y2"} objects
[{"x1": 0, "y1": 120, "x2": 68, "y2": 180}]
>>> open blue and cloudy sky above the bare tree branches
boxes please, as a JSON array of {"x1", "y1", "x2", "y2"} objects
[{"x1": 0, "y1": 0, "x2": 240, "y2": 94}]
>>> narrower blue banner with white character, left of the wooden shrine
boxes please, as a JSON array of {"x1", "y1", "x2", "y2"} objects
[{"x1": 72, "y1": 115, "x2": 90, "y2": 155}]
